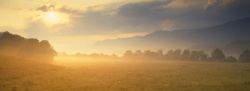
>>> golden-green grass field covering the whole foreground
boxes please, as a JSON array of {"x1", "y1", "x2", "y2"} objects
[{"x1": 0, "y1": 58, "x2": 250, "y2": 91}]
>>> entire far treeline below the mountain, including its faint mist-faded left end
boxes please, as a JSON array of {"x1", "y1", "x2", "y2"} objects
[{"x1": 65, "y1": 48, "x2": 250, "y2": 62}]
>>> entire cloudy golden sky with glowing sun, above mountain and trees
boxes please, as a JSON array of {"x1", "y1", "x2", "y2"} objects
[{"x1": 0, "y1": 0, "x2": 250, "y2": 54}]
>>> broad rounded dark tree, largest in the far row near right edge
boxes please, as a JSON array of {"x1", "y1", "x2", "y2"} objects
[{"x1": 211, "y1": 48, "x2": 226, "y2": 61}]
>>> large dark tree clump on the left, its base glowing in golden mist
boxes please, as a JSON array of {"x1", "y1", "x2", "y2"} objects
[{"x1": 0, "y1": 31, "x2": 56, "y2": 61}]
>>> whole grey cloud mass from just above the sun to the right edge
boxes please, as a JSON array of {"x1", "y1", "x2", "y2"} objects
[{"x1": 32, "y1": 0, "x2": 250, "y2": 36}]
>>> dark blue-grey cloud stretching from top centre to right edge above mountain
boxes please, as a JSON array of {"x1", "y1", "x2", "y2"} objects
[{"x1": 118, "y1": 0, "x2": 250, "y2": 28}]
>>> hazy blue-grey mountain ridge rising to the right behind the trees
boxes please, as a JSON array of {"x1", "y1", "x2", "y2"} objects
[{"x1": 94, "y1": 17, "x2": 250, "y2": 54}]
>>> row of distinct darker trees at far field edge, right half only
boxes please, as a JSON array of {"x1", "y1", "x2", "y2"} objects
[{"x1": 123, "y1": 48, "x2": 250, "y2": 62}]
